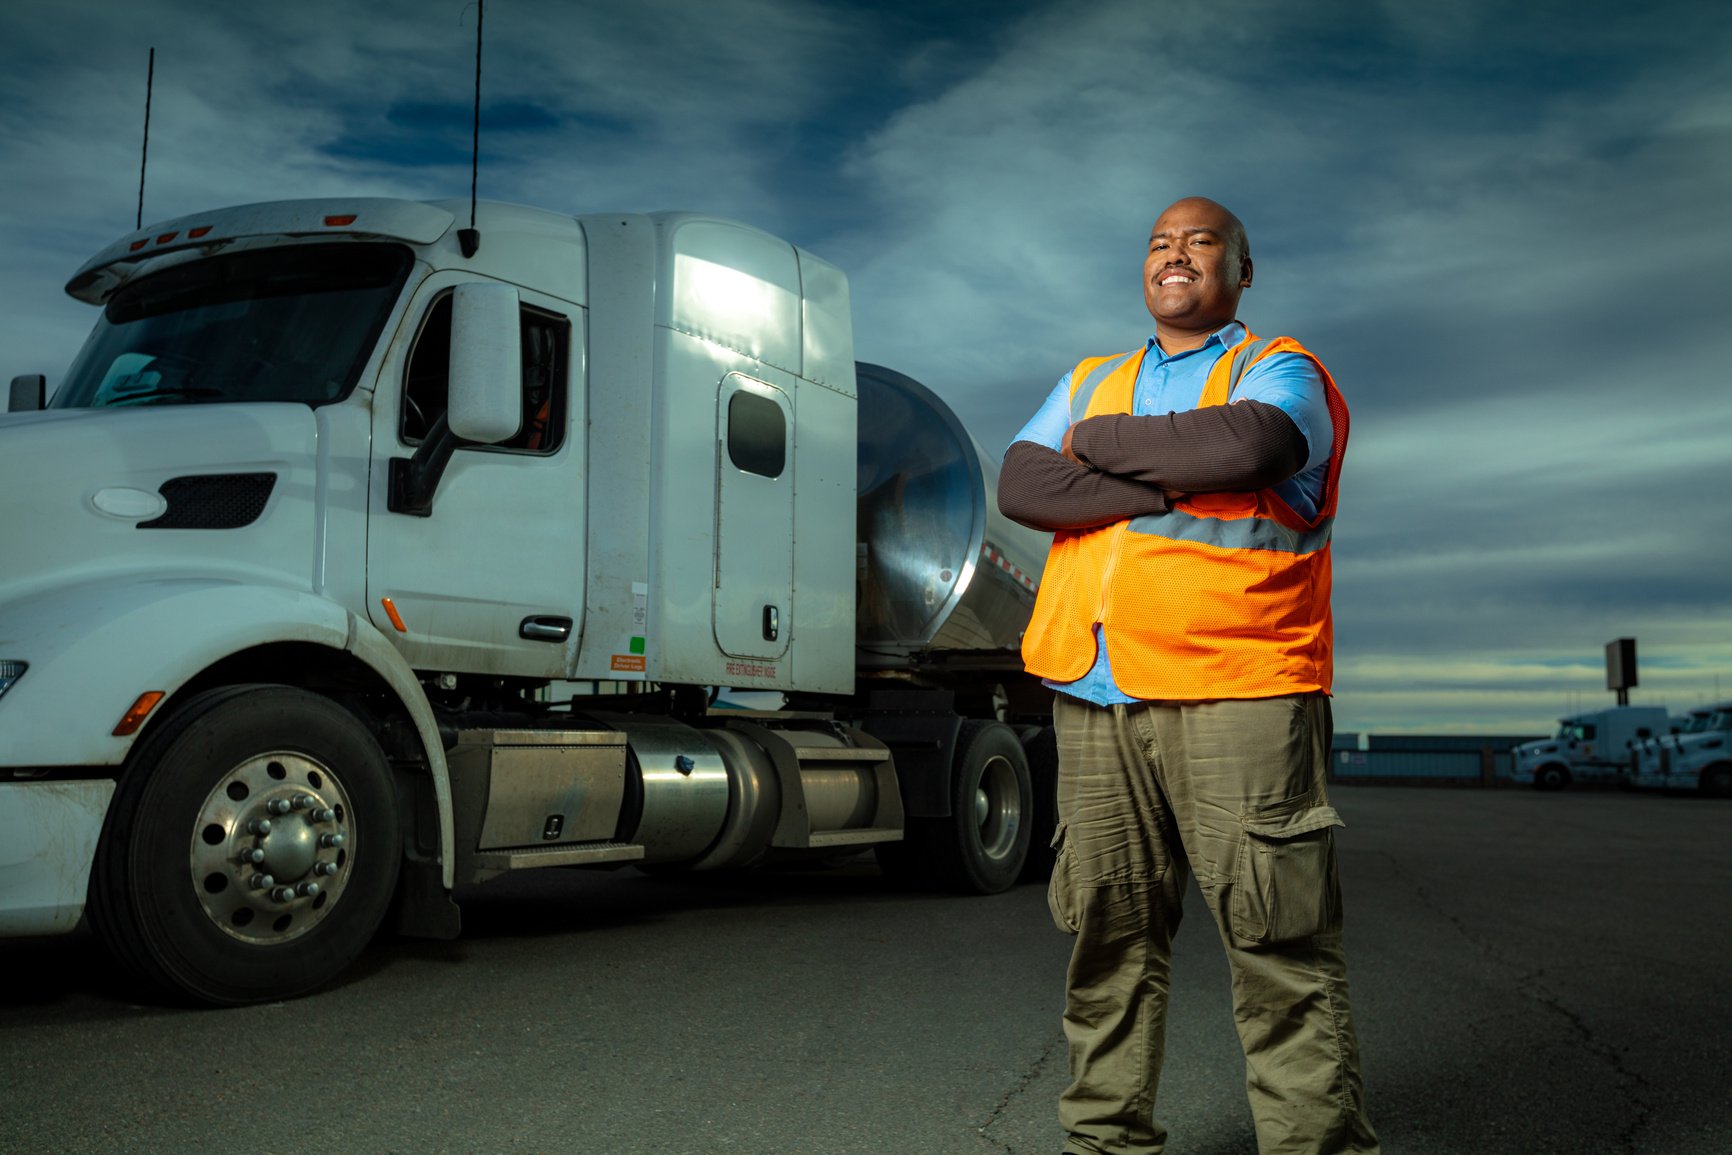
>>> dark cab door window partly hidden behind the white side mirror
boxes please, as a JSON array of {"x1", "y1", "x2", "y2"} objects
[{"x1": 400, "y1": 293, "x2": 572, "y2": 454}]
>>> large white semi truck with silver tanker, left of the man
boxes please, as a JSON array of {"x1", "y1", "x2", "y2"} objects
[{"x1": 0, "y1": 199, "x2": 1055, "y2": 1004}]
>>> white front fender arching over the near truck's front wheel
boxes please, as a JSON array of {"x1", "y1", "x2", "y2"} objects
[{"x1": 0, "y1": 573, "x2": 454, "y2": 888}]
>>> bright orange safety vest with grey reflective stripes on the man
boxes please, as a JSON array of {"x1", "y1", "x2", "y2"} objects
[{"x1": 1022, "y1": 332, "x2": 1347, "y2": 700}]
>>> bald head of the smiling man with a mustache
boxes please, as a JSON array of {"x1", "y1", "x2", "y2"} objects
[{"x1": 1143, "y1": 197, "x2": 1251, "y2": 353}]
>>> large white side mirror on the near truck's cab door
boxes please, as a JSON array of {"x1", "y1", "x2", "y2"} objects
[{"x1": 447, "y1": 281, "x2": 523, "y2": 445}]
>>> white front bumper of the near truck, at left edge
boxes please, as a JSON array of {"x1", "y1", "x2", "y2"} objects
[{"x1": 0, "y1": 779, "x2": 114, "y2": 939}]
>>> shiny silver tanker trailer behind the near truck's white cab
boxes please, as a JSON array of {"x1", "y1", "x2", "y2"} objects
[{"x1": 856, "y1": 362, "x2": 1051, "y2": 667}]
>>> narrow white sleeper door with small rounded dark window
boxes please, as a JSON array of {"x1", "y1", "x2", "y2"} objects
[{"x1": 714, "y1": 372, "x2": 793, "y2": 661}]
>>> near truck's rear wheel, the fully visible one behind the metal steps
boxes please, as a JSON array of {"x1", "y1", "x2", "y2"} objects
[{"x1": 878, "y1": 720, "x2": 1034, "y2": 894}]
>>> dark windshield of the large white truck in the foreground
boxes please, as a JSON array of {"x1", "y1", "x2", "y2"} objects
[{"x1": 50, "y1": 242, "x2": 410, "y2": 409}]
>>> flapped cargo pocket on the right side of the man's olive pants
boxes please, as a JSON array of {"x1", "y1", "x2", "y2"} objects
[{"x1": 1228, "y1": 795, "x2": 1346, "y2": 945}]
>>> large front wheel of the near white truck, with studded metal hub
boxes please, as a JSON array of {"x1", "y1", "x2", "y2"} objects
[{"x1": 90, "y1": 686, "x2": 402, "y2": 1006}]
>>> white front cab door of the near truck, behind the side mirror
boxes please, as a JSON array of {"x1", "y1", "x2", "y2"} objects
[{"x1": 367, "y1": 274, "x2": 585, "y2": 677}]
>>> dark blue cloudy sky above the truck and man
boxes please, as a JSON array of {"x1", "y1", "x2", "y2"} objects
[{"x1": 0, "y1": 0, "x2": 1732, "y2": 732}]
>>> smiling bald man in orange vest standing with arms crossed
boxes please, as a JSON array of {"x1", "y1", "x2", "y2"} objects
[{"x1": 998, "y1": 197, "x2": 1379, "y2": 1155}]
